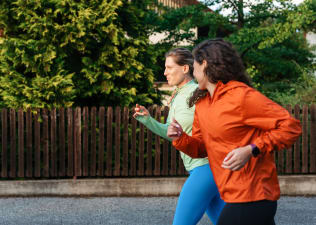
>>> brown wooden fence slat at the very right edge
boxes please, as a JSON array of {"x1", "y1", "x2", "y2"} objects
[{"x1": 309, "y1": 104, "x2": 316, "y2": 173}]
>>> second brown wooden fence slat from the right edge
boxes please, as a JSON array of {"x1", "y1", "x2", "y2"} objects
[{"x1": 302, "y1": 105, "x2": 308, "y2": 173}]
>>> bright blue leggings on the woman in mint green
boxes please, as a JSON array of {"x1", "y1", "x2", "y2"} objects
[{"x1": 173, "y1": 164, "x2": 225, "y2": 225}]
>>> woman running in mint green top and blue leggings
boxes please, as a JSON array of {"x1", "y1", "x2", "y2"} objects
[{"x1": 134, "y1": 48, "x2": 225, "y2": 225}]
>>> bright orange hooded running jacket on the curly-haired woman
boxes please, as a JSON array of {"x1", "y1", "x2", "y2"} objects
[{"x1": 173, "y1": 81, "x2": 301, "y2": 203}]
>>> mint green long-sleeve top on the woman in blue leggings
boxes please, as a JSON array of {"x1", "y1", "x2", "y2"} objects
[{"x1": 136, "y1": 80, "x2": 208, "y2": 171}]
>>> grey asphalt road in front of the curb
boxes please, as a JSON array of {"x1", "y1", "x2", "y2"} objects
[{"x1": 0, "y1": 197, "x2": 316, "y2": 225}]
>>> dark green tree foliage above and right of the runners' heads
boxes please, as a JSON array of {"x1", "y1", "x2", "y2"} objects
[{"x1": 152, "y1": 0, "x2": 316, "y2": 103}]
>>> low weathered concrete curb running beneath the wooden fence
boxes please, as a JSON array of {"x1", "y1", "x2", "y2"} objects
[{"x1": 0, "y1": 175, "x2": 316, "y2": 197}]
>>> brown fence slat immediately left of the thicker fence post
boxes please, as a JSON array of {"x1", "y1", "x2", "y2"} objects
[{"x1": 67, "y1": 108, "x2": 74, "y2": 176}]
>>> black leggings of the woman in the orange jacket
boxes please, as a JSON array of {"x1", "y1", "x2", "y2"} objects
[{"x1": 217, "y1": 200, "x2": 277, "y2": 225}]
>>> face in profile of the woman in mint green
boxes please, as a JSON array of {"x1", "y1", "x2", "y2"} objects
[{"x1": 164, "y1": 56, "x2": 186, "y2": 87}]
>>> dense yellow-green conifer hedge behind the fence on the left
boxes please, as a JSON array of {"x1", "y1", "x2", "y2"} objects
[{"x1": 0, "y1": 0, "x2": 160, "y2": 109}]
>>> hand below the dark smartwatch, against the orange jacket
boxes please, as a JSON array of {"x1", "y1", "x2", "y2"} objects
[{"x1": 222, "y1": 145, "x2": 252, "y2": 171}]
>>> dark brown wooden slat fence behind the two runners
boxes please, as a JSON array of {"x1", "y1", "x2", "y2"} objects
[{"x1": 0, "y1": 105, "x2": 316, "y2": 179}]
